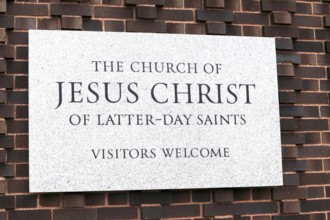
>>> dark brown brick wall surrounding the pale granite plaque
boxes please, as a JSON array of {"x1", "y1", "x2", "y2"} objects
[{"x1": 0, "y1": 0, "x2": 330, "y2": 220}]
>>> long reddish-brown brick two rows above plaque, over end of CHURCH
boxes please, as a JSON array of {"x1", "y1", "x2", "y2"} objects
[{"x1": 157, "y1": 9, "x2": 194, "y2": 21}]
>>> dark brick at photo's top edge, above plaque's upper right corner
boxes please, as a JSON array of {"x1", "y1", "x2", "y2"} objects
[{"x1": 261, "y1": 0, "x2": 297, "y2": 12}]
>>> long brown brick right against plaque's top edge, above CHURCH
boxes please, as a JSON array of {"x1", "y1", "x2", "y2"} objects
[{"x1": 126, "y1": 20, "x2": 166, "y2": 33}]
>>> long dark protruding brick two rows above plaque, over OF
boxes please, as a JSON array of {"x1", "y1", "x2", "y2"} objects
[{"x1": 196, "y1": 9, "x2": 234, "y2": 22}]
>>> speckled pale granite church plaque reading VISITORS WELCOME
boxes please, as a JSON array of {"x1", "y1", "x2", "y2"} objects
[{"x1": 29, "y1": 30, "x2": 282, "y2": 192}]
